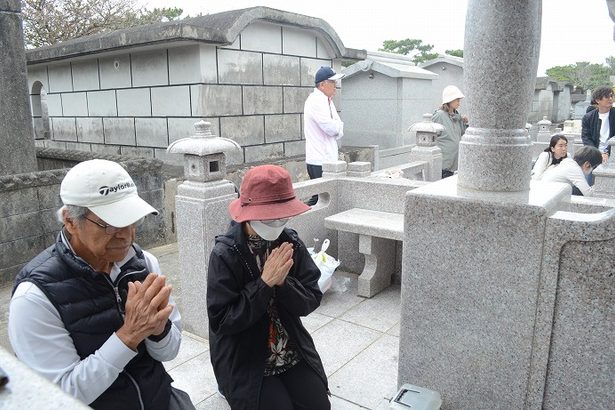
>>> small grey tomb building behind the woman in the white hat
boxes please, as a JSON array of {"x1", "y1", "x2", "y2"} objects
[{"x1": 340, "y1": 52, "x2": 437, "y2": 169}]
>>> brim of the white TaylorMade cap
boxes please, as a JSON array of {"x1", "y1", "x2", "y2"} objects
[{"x1": 88, "y1": 194, "x2": 158, "y2": 228}]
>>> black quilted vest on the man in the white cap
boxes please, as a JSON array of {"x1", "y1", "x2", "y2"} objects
[{"x1": 13, "y1": 235, "x2": 173, "y2": 410}]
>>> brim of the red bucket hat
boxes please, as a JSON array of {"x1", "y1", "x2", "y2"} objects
[{"x1": 228, "y1": 198, "x2": 312, "y2": 222}]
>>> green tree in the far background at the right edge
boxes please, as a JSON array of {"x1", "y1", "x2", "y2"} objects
[{"x1": 546, "y1": 57, "x2": 615, "y2": 90}]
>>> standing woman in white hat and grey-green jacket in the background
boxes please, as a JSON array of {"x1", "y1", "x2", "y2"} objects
[{"x1": 432, "y1": 85, "x2": 468, "y2": 178}]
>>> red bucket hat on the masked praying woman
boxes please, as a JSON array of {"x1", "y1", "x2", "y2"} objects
[{"x1": 228, "y1": 165, "x2": 311, "y2": 222}]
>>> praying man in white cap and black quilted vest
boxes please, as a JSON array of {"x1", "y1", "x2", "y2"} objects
[{"x1": 8, "y1": 159, "x2": 194, "y2": 410}]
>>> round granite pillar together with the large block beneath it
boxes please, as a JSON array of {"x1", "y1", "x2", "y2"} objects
[{"x1": 398, "y1": 0, "x2": 552, "y2": 410}]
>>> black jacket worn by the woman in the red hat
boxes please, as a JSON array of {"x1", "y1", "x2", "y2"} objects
[{"x1": 207, "y1": 223, "x2": 327, "y2": 410}]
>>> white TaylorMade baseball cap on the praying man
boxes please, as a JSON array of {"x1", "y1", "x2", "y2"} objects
[{"x1": 60, "y1": 159, "x2": 158, "y2": 228}]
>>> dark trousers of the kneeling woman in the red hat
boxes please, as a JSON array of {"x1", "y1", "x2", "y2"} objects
[{"x1": 259, "y1": 360, "x2": 331, "y2": 410}]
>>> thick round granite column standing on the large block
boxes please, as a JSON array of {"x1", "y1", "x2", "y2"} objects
[{"x1": 458, "y1": 0, "x2": 541, "y2": 192}]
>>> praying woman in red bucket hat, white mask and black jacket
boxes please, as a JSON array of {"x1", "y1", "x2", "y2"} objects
[{"x1": 207, "y1": 165, "x2": 331, "y2": 410}]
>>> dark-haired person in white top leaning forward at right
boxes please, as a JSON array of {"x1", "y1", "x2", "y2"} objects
[{"x1": 542, "y1": 145, "x2": 602, "y2": 196}]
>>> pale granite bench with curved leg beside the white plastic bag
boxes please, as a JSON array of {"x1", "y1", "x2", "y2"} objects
[{"x1": 325, "y1": 208, "x2": 404, "y2": 298}]
